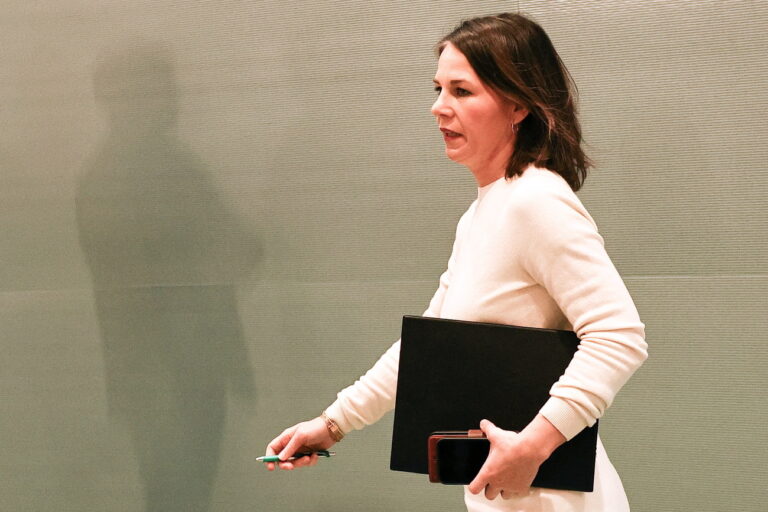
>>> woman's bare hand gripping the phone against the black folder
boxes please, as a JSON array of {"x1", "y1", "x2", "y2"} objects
[{"x1": 469, "y1": 415, "x2": 565, "y2": 500}]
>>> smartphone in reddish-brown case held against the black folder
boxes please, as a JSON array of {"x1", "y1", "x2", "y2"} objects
[{"x1": 428, "y1": 430, "x2": 491, "y2": 485}]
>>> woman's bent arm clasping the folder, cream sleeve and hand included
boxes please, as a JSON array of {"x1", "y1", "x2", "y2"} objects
[{"x1": 469, "y1": 175, "x2": 647, "y2": 499}]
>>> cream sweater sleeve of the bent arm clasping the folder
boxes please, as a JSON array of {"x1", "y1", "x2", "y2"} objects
[{"x1": 512, "y1": 175, "x2": 647, "y2": 439}]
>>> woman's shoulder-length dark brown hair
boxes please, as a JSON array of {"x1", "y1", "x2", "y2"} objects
[{"x1": 437, "y1": 13, "x2": 592, "y2": 191}]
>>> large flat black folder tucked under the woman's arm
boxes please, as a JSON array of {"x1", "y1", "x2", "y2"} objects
[{"x1": 390, "y1": 316, "x2": 597, "y2": 492}]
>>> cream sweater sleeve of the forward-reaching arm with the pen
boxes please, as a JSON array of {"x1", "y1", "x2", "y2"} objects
[{"x1": 326, "y1": 206, "x2": 472, "y2": 433}]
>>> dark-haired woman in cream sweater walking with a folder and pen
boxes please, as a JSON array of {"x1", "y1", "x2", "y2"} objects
[{"x1": 267, "y1": 14, "x2": 647, "y2": 512}]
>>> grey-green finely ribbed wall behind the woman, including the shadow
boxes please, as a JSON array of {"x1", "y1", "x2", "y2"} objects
[{"x1": 0, "y1": 0, "x2": 768, "y2": 512}]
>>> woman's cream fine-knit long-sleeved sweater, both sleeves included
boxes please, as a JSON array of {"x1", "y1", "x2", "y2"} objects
[{"x1": 327, "y1": 167, "x2": 647, "y2": 439}]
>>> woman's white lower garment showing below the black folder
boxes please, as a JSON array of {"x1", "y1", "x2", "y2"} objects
[{"x1": 464, "y1": 436, "x2": 629, "y2": 512}]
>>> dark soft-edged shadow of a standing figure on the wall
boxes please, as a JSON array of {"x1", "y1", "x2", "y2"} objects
[{"x1": 76, "y1": 43, "x2": 260, "y2": 512}]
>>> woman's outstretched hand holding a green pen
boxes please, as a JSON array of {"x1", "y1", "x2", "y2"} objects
[{"x1": 266, "y1": 416, "x2": 336, "y2": 471}]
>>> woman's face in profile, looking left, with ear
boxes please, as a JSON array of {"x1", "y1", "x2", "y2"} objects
[{"x1": 432, "y1": 43, "x2": 525, "y2": 185}]
